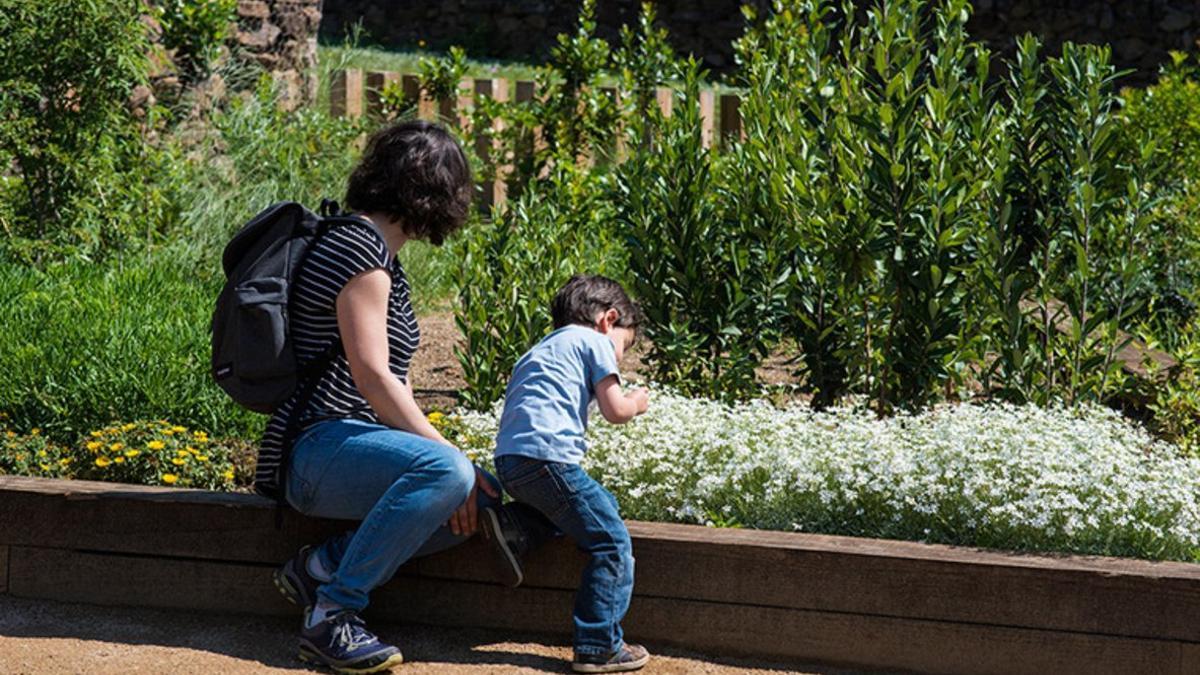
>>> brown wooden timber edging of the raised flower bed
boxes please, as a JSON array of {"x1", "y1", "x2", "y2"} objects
[{"x1": 0, "y1": 477, "x2": 1200, "y2": 674}]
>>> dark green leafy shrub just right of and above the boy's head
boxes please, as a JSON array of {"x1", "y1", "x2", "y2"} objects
[{"x1": 614, "y1": 64, "x2": 782, "y2": 399}]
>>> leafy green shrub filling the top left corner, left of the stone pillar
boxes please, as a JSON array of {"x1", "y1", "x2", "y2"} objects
[{"x1": 0, "y1": 0, "x2": 148, "y2": 245}]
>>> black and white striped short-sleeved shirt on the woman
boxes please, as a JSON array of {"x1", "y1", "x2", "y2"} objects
[{"x1": 254, "y1": 218, "x2": 421, "y2": 496}]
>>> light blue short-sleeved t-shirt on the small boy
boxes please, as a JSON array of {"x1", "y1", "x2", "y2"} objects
[{"x1": 496, "y1": 325, "x2": 618, "y2": 464}]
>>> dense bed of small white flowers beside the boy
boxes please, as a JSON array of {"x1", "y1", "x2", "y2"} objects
[{"x1": 455, "y1": 392, "x2": 1200, "y2": 561}]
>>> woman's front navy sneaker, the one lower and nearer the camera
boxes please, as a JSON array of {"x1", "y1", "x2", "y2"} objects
[{"x1": 300, "y1": 609, "x2": 404, "y2": 674}]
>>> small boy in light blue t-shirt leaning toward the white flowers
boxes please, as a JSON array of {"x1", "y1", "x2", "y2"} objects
[{"x1": 481, "y1": 275, "x2": 650, "y2": 673}]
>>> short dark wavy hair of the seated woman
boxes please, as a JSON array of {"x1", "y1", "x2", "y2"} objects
[{"x1": 346, "y1": 120, "x2": 474, "y2": 246}]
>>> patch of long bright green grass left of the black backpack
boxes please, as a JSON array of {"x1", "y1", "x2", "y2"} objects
[{"x1": 0, "y1": 255, "x2": 264, "y2": 442}]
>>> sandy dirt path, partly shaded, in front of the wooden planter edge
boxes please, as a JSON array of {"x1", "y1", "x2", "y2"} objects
[{"x1": 0, "y1": 595, "x2": 845, "y2": 675}]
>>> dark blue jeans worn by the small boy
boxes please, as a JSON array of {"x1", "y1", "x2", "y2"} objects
[{"x1": 496, "y1": 455, "x2": 634, "y2": 655}]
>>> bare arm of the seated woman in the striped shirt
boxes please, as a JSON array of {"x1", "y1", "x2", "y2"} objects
[{"x1": 337, "y1": 269, "x2": 450, "y2": 446}]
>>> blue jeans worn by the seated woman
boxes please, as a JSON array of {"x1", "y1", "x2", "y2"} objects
[{"x1": 287, "y1": 419, "x2": 499, "y2": 610}]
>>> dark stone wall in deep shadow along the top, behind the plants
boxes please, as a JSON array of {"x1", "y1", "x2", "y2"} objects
[{"x1": 320, "y1": 0, "x2": 1200, "y2": 79}]
